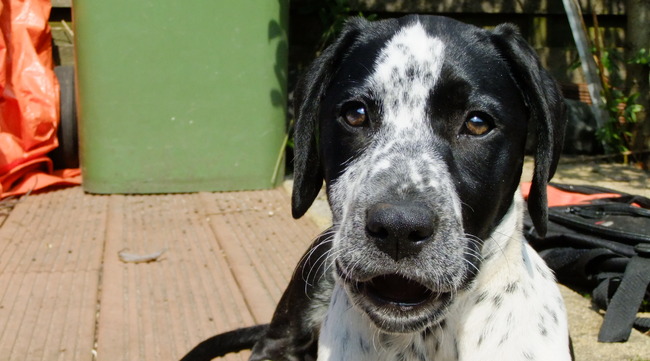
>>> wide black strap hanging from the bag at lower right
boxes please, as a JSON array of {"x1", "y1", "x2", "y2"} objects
[{"x1": 594, "y1": 250, "x2": 650, "y2": 342}]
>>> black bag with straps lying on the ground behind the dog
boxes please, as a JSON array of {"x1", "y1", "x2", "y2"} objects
[{"x1": 524, "y1": 184, "x2": 650, "y2": 342}]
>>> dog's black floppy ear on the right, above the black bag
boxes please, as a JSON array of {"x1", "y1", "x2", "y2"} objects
[{"x1": 492, "y1": 24, "x2": 567, "y2": 236}]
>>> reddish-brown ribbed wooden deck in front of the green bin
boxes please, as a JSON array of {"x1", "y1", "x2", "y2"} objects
[{"x1": 0, "y1": 187, "x2": 319, "y2": 361}]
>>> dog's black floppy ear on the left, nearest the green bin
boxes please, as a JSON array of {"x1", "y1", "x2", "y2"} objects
[{"x1": 291, "y1": 18, "x2": 368, "y2": 218}]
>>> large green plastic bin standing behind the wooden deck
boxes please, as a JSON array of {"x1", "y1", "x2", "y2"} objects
[{"x1": 73, "y1": 0, "x2": 288, "y2": 193}]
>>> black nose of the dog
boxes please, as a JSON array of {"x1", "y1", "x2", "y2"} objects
[{"x1": 366, "y1": 202, "x2": 435, "y2": 261}]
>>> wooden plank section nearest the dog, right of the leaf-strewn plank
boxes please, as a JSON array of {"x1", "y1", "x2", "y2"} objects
[{"x1": 201, "y1": 189, "x2": 318, "y2": 323}]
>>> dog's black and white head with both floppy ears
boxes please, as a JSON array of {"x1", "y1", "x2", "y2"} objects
[{"x1": 292, "y1": 16, "x2": 565, "y2": 332}]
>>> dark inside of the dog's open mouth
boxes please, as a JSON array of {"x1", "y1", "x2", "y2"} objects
[{"x1": 367, "y1": 275, "x2": 432, "y2": 305}]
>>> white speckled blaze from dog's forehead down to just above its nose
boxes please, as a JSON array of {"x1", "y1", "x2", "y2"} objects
[{"x1": 330, "y1": 23, "x2": 462, "y2": 225}]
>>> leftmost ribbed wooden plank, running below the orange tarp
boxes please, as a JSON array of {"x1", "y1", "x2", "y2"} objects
[{"x1": 0, "y1": 187, "x2": 107, "y2": 361}]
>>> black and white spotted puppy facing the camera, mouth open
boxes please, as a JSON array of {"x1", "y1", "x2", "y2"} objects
[{"x1": 184, "y1": 16, "x2": 571, "y2": 361}]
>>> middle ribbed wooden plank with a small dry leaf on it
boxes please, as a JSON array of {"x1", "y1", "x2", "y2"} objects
[{"x1": 97, "y1": 194, "x2": 253, "y2": 361}]
